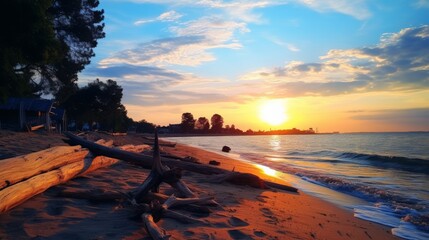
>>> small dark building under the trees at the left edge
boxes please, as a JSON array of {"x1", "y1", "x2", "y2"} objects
[{"x1": 0, "y1": 98, "x2": 65, "y2": 131}]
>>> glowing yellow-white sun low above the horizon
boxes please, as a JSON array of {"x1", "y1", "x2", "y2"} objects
[{"x1": 259, "y1": 99, "x2": 288, "y2": 126}]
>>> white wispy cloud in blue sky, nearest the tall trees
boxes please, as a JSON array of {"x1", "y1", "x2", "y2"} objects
[{"x1": 99, "y1": 17, "x2": 249, "y2": 67}]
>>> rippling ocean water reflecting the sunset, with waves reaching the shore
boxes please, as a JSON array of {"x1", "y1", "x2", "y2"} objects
[{"x1": 165, "y1": 132, "x2": 429, "y2": 240}]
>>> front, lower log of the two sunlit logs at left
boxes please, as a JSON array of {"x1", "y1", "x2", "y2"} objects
[{"x1": 0, "y1": 156, "x2": 118, "y2": 213}]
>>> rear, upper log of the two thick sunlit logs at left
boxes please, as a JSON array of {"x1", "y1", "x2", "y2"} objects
[{"x1": 0, "y1": 146, "x2": 88, "y2": 190}]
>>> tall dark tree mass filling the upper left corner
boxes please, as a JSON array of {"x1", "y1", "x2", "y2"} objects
[{"x1": 0, "y1": 0, "x2": 104, "y2": 102}]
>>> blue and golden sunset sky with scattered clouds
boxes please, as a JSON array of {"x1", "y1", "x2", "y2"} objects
[{"x1": 79, "y1": 0, "x2": 429, "y2": 132}]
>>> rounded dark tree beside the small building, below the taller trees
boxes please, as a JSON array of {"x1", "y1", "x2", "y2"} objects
[{"x1": 64, "y1": 79, "x2": 132, "y2": 131}]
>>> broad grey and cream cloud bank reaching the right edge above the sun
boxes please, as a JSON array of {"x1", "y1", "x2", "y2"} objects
[{"x1": 242, "y1": 26, "x2": 429, "y2": 97}]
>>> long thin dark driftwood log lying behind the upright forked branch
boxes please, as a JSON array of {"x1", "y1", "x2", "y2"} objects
[{"x1": 64, "y1": 132, "x2": 298, "y2": 192}]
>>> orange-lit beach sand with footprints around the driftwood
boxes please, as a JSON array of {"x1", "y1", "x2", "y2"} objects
[{"x1": 0, "y1": 131, "x2": 397, "y2": 239}]
